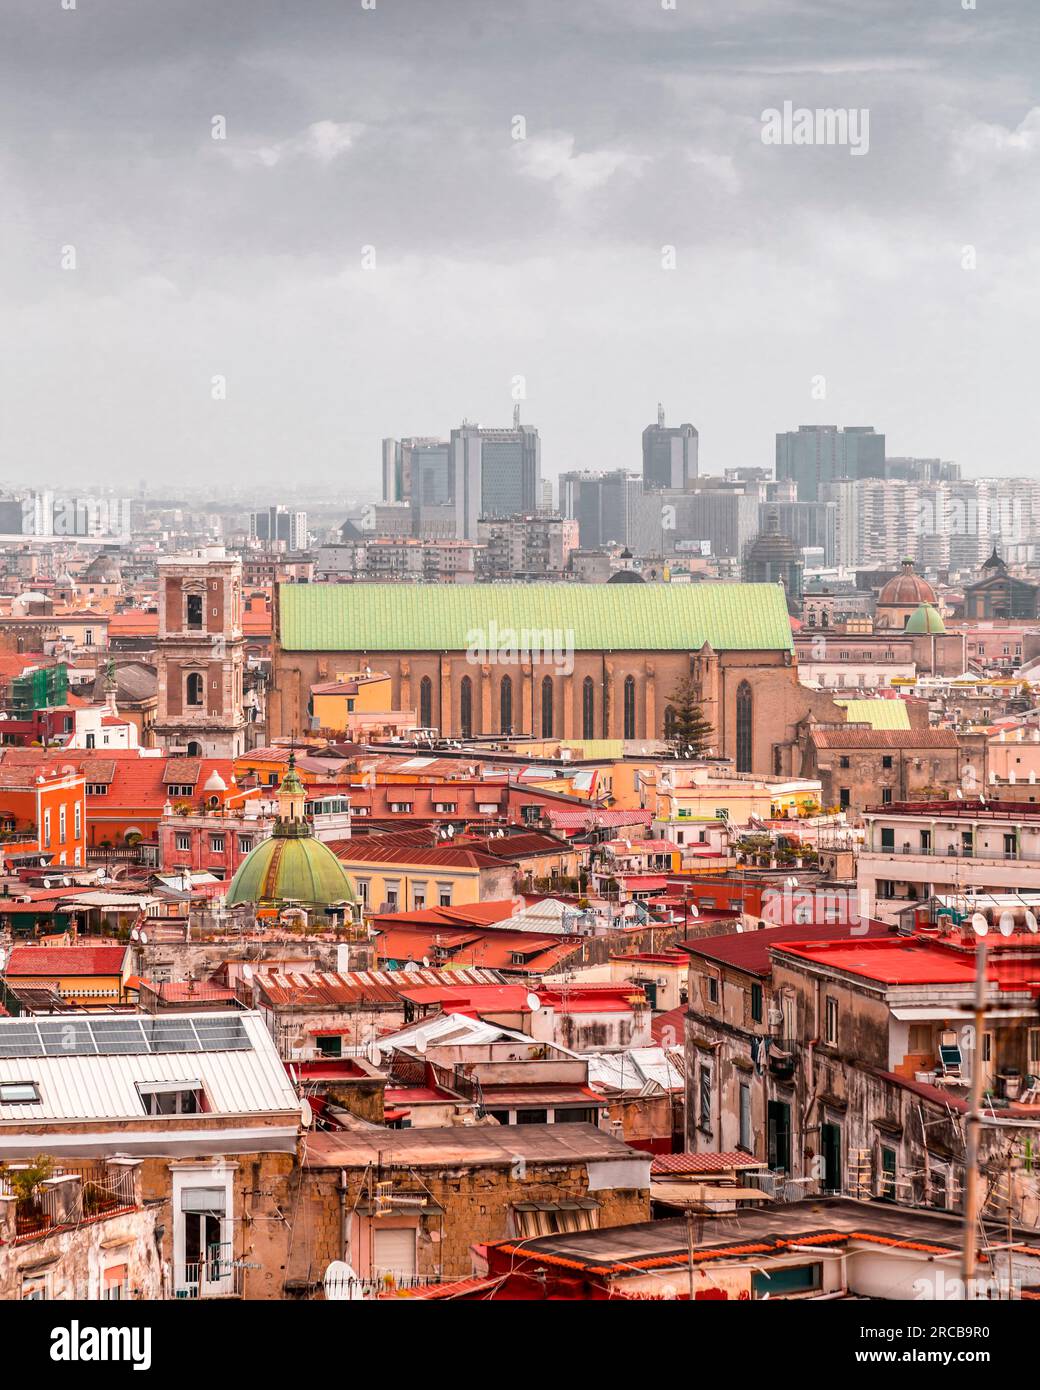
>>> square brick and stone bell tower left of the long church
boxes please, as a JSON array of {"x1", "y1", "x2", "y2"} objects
[{"x1": 153, "y1": 546, "x2": 246, "y2": 758}]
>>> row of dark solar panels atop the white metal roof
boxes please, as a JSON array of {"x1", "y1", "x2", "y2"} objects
[{"x1": 0, "y1": 1015, "x2": 252, "y2": 1056}]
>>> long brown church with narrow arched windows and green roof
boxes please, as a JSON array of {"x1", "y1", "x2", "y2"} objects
[{"x1": 268, "y1": 582, "x2": 844, "y2": 774}]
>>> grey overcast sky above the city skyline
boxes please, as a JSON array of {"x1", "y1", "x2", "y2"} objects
[{"x1": 0, "y1": 0, "x2": 1040, "y2": 496}]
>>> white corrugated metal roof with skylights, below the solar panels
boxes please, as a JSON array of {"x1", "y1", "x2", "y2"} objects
[{"x1": 0, "y1": 1011, "x2": 300, "y2": 1117}]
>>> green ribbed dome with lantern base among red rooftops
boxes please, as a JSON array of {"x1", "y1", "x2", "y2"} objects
[{"x1": 225, "y1": 823, "x2": 355, "y2": 908}]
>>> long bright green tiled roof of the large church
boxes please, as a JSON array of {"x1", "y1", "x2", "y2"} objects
[{"x1": 278, "y1": 581, "x2": 794, "y2": 652}]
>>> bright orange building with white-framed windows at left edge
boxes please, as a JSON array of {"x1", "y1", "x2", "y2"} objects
[{"x1": 0, "y1": 765, "x2": 86, "y2": 865}]
